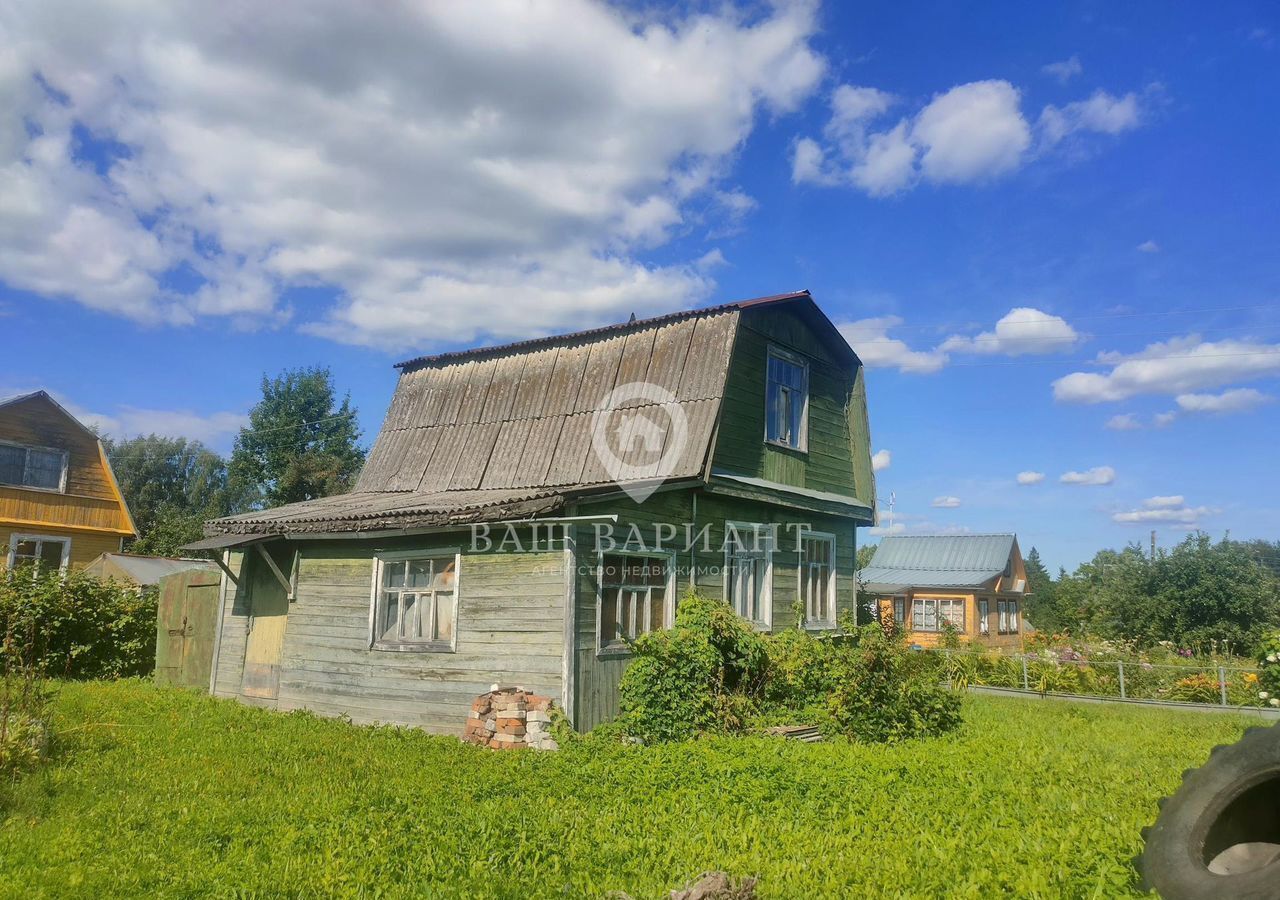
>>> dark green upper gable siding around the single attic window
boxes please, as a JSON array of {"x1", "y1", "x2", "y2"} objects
[{"x1": 713, "y1": 307, "x2": 874, "y2": 503}]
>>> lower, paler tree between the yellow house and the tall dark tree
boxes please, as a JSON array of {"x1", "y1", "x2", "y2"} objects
[{"x1": 104, "y1": 434, "x2": 241, "y2": 556}]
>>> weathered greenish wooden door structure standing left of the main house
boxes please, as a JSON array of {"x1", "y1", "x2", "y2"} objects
[{"x1": 156, "y1": 570, "x2": 221, "y2": 690}]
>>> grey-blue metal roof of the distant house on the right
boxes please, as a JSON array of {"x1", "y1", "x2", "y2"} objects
[{"x1": 858, "y1": 534, "x2": 1018, "y2": 594}]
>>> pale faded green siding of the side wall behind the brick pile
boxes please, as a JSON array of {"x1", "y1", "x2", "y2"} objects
[{"x1": 218, "y1": 533, "x2": 566, "y2": 734}]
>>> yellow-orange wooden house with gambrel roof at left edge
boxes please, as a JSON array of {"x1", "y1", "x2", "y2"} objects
[{"x1": 0, "y1": 390, "x2": 137, "y2": 571}]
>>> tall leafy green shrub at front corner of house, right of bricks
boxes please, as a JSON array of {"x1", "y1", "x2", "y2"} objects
[{"x1": 618, "y1": 593, "x2": 768, "y2": 741}]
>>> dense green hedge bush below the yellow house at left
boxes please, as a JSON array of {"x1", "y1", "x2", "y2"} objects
[{"x1": 0, "y1": 570, "x2": 156, "y2": 679}]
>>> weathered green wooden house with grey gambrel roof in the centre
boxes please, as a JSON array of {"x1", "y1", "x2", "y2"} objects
[{"x1": 192, "y1": 292, "x2": 876, "y2": 732}]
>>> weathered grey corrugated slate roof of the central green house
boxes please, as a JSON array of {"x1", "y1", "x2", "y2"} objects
[{"x1": 205, "y1": 291, "x2": 858, "y2": 535}]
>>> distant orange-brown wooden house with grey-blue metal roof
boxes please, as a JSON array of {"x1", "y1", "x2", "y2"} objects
[{"x1": 859, "y1": 534, "x2": 1027, "y2": 649}]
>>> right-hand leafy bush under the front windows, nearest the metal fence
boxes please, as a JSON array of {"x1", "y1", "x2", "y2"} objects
[{"x1": 827, "y1": 626, "x2": 961, "y2": 744}]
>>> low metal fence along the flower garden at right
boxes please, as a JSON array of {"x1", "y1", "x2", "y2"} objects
[{"x1": 922, "y1": 648, "x2": 1271, "y2": 709}]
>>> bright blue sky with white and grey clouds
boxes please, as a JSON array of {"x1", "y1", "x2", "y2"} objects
[{"x1": 0, "y1": 0, "x2": 1280, "y2": 566}]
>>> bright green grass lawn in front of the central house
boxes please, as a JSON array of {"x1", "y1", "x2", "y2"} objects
[{"x1": 0, "y1": 681, "x2": 1249, "y2": 897}]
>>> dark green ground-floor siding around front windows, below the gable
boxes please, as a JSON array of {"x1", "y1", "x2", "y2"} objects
[{"x1": 573, "y1": 489, "x2": 855, "y2": 730}]
